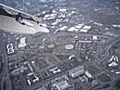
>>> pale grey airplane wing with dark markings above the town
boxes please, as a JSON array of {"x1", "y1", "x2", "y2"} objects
[{"x1": 0, "y1": 3, "x2": 49, "y2": 34}]
